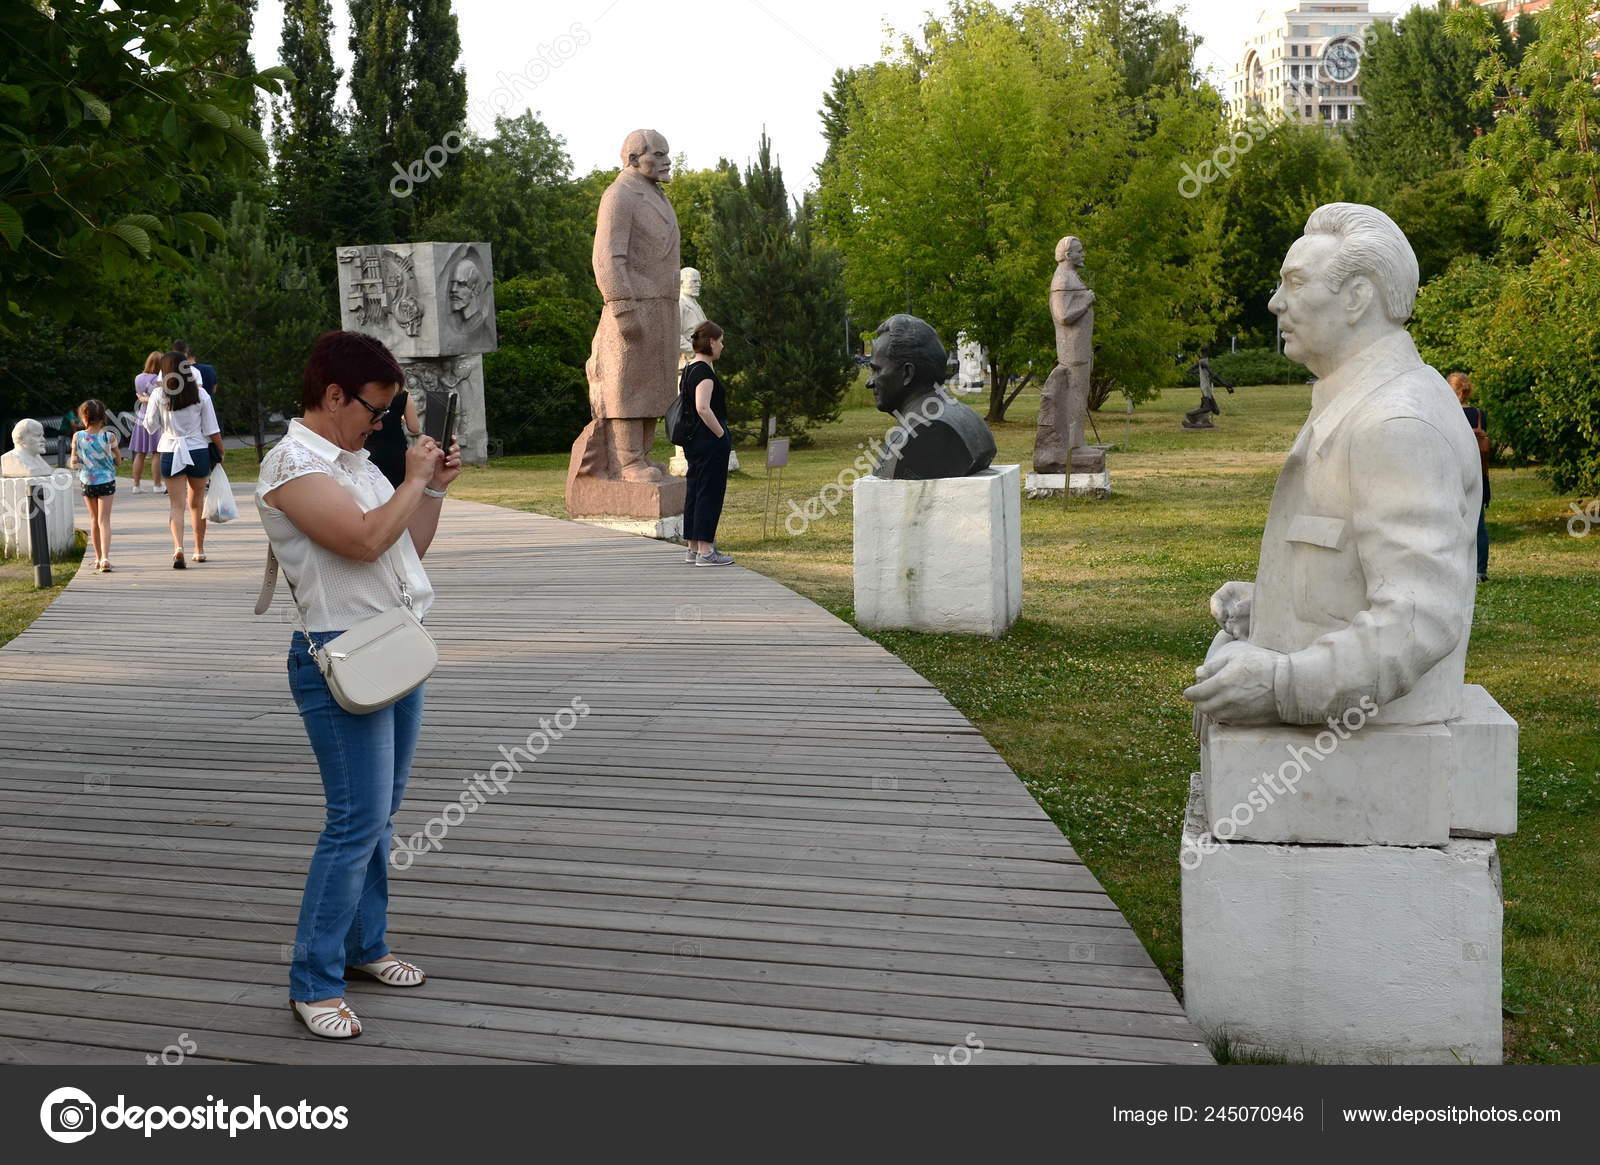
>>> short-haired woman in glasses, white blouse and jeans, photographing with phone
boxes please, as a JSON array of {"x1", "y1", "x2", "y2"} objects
[{"x1": 256, "y1": 331, "x2": 461, "y2": 1040}]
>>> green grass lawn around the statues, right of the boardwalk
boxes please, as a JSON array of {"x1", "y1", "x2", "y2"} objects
[{"x1": 453, "y1": 386, "x2": 1600, "y2": 1063}]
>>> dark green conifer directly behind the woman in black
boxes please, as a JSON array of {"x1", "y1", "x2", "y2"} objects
[{"x1": 704, "y1": 134, "x2": 856, "y2": 443}]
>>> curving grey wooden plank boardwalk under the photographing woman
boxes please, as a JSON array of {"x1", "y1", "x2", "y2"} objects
[{"x1": 0, "y1": 486, "x2": 1210, "y2": 1064}]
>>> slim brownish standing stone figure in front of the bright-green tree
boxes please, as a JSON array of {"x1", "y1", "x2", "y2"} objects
[{"x1": 1034, "y1": 235, "x2": 1104, "y2": 474}]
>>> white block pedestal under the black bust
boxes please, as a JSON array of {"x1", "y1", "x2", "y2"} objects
[{"x1": 853, "y1": 466, "x2": 1022, "y2": 639}]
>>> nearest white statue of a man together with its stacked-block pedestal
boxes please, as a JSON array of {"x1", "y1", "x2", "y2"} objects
[{"x1": 1179, "y1": 203, "x2": 1497, "y2": 1063}]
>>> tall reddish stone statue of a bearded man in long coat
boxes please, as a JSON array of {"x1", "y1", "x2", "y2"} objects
[{"x1": 566, "y1": 130, "x2": 683, "y2": 518}]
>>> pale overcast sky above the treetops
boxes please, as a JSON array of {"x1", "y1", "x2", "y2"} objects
[{"x1": 253, "y1": 0, "x2": 1416, "y2": 190}]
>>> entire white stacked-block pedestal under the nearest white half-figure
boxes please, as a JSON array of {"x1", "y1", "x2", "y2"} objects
[{"x1": 1179, "y1": 685, "x2": 1517, "y2": 1064}]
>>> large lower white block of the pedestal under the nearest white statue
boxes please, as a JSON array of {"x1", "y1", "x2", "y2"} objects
[{"x1": 1179, "y1": 778, "x2": 1502, "y2": 1064}]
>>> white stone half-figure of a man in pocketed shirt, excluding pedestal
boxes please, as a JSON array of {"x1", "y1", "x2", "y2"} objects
[{"x1": 1184, "y1": 203, "x2": 1482, "y2": 725}]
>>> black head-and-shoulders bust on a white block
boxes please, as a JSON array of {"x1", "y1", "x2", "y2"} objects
[{"x1": 867, "y1": 315, "x2": 995, "y2": 480}]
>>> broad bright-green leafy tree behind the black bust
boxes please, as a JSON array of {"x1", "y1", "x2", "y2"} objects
[{"x1": 819, "y1": 3, "x2": 1222, "y2": 421}]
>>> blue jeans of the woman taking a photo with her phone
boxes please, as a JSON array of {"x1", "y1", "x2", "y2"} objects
[{"x1": 288, "y1": 631, "x2": 424, "y2": 1003}]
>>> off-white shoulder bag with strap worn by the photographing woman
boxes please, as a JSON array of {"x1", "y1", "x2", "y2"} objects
[{"x1": 256, "y1": 546, "x2": 438, "y2": 715}]
